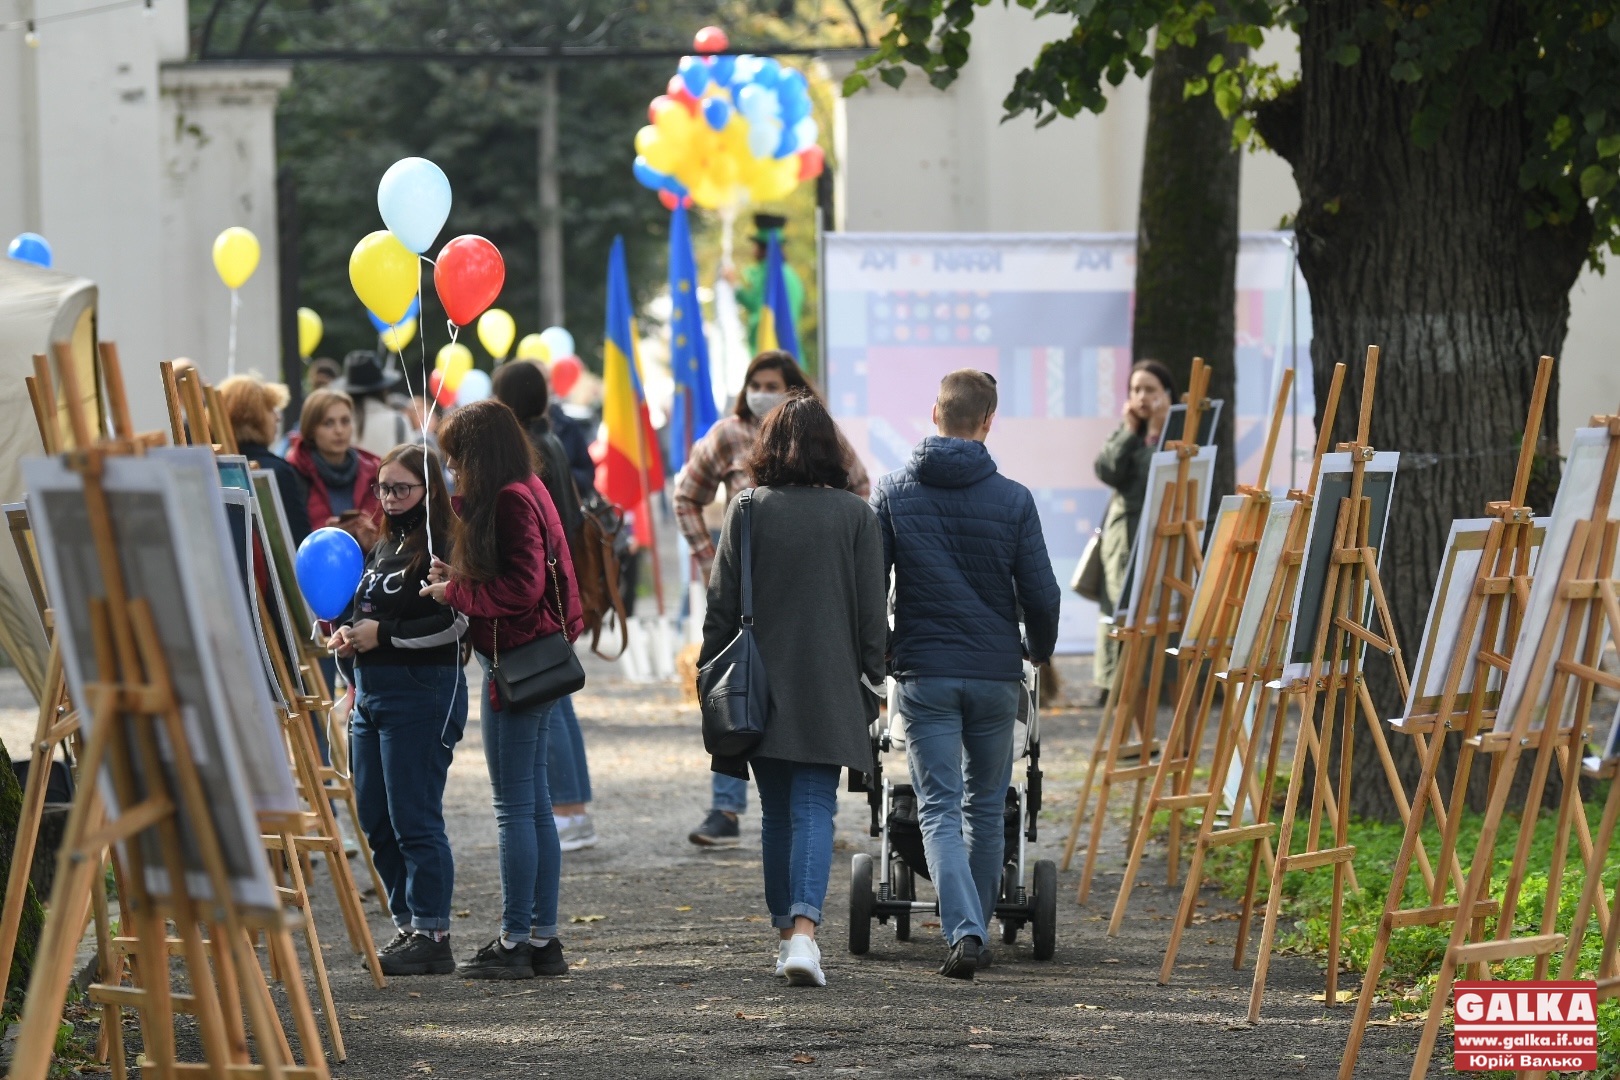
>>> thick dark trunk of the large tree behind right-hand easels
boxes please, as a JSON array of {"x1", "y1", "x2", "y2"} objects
[{"x1": 1257, "y1": 0, "x2": 1591, "y2": 819}]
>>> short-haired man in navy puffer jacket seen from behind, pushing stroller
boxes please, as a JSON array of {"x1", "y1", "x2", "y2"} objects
[{"x1": 872, "y1": 369, "x2": 1059, "y2": 978}]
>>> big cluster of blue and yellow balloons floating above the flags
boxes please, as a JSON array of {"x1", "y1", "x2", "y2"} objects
[{"x1": 633, "y1": 26, "x2": 826, "y2": 209}]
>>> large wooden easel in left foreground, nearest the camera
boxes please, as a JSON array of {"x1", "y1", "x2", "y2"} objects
[{"x1": 10, "y1": 351, "x2": 329, "y2": 1080}]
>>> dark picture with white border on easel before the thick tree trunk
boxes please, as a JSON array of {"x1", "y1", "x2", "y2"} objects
[{"x1": 1283, "y1": 450, "x2": 1401, "y2": 683}]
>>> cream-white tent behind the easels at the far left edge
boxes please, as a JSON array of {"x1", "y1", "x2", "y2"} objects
[{"x1": 0, "y1": 259, "x2": 105, "y2": 698}]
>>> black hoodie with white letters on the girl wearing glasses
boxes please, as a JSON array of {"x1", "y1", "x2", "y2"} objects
[{"x1": 347, "y1": 536, "x2": 467, "y2": 667}]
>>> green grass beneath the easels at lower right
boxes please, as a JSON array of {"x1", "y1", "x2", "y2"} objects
[{"x1": 1205, "y1": 787, "x2": 1620, "y2": 1080}]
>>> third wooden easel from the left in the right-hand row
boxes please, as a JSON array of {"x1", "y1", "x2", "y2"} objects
[{"x1": 1158, "y1": 364, "x2": 1345, "y2": 986}]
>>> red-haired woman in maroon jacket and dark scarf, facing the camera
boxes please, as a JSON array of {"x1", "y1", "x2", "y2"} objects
[{"x1": 287, "y1": 390, "x2": 382, "y2": 551}]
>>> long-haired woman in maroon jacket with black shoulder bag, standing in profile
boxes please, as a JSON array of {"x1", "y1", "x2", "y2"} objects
[{"x1": 423, "y1": 398, "x2": 582, "y2": 980}]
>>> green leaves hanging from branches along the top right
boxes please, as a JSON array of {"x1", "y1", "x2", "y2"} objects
[{"x1": 844, "y1": 0, "x2": 1620, "y2": 266}]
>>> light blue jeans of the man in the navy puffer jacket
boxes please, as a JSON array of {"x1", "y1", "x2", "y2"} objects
[{"x1": 897, "y1": 677, "x2": 1019, "y2": 946}]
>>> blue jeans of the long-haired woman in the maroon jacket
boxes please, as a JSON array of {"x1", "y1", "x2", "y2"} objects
[{"x1": 478, "y1": 656, "x2": 562, "y2": 939}]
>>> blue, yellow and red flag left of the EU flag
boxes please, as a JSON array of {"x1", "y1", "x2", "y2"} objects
[{"x1": 596, "y1": 236, "x2": 664, "y2": 541}]
